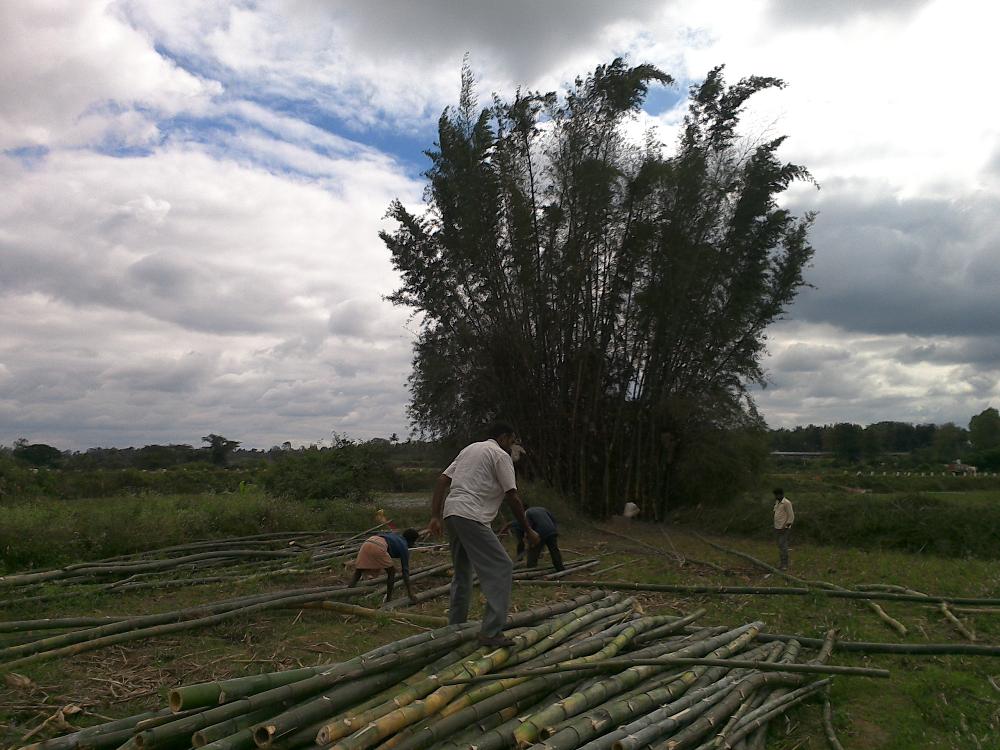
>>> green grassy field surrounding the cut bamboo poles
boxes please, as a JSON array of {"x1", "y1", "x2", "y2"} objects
[{"x1": 0, "y1": 478, "x2": 1000, "y2": 750}]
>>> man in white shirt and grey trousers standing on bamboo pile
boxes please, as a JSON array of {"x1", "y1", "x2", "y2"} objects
[{"x1": 428, "y1": 422, "x2": 540, "y2": 647}]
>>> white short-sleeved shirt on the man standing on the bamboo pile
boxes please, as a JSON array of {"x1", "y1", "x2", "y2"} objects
[{"x1": 442, "y1": 439, "x2": 517, "y2": 524}]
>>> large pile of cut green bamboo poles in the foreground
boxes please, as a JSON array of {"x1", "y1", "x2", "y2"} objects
[{"x1": 22, "y1": 592, "x2": 887, "y2": 750}]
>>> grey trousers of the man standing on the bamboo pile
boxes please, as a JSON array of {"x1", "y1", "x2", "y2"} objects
[{"x1": 444, "y1": 516, "x2": 514, "y2": 637}]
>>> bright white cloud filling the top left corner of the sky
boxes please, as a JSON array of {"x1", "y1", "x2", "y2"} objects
[{"x1": 0, "y1": 0, "x2": 221, "y2": 148}]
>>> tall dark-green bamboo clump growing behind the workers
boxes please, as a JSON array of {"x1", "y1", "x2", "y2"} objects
[{"x1": 382, "y1": 59, "x2": 813, "y2": 516}]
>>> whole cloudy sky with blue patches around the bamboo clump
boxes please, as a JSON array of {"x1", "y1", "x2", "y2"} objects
[{"x1": 0, "y1": 0, "x2": 1000, "y2": 449}]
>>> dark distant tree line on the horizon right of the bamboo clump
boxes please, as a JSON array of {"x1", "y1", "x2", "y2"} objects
[{"x1": 770, "y1": 407, "x2": 1000, "y2": 470}]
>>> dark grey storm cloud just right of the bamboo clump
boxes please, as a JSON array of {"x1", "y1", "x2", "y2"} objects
[{"x1": 789, "y1": 188, "x2": 1000, "y2": 336}]
